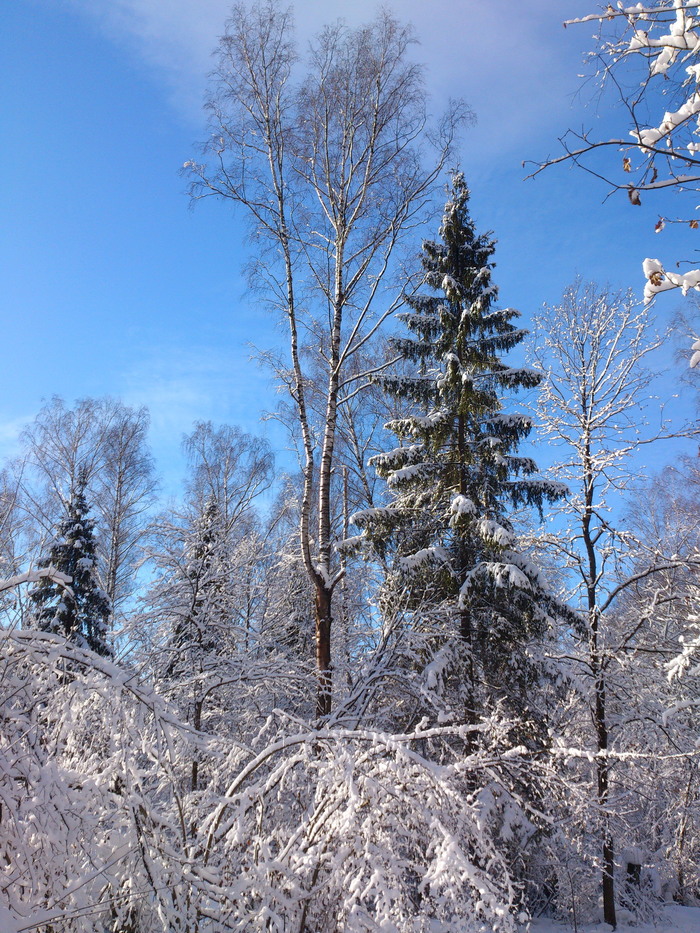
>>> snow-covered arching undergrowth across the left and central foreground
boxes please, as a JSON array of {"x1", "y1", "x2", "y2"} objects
[{"x1": 0, "y1": 631, "x2": 548, "y2": 933}]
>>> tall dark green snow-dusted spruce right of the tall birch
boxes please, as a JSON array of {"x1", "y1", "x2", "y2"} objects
[{"x1": 354, "y1": 172, "x2": 562, "y2": 725}]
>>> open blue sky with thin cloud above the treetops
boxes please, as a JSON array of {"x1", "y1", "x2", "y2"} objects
[{"x1": 0, "y1": 0, "x2": 689, "y2": 486}]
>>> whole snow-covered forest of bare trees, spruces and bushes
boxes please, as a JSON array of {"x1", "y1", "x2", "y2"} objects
[{"x1": 0, "y1": 0, "x2": 700, "y2": 933}]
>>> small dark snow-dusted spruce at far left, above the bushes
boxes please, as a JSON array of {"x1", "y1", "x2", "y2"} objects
[{"x1": 29, "y1": 470, "x2": 111, "y2": 656}]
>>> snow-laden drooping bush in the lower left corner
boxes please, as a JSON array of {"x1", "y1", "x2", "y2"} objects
[{"x1": 0, "y1": 631, "x2": 205, "y2": 933}]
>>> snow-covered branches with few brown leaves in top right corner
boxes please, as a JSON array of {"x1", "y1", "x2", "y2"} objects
[{"x1": 532, "y1": 0, "x2": 700, "y2": 334}]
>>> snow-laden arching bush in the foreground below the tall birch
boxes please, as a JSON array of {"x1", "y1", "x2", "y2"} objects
[{"x1": 194, "y1": 708, "x2": 540, "y2": 933}]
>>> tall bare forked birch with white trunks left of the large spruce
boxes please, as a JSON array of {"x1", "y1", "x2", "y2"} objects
[{"x1": 185, "y1": 2, "x2": 463, "y2": 717}]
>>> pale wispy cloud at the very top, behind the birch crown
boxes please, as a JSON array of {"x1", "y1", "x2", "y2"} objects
[{"x1": 71, "y1": 0, "x2": 586, "y2": 160}]
